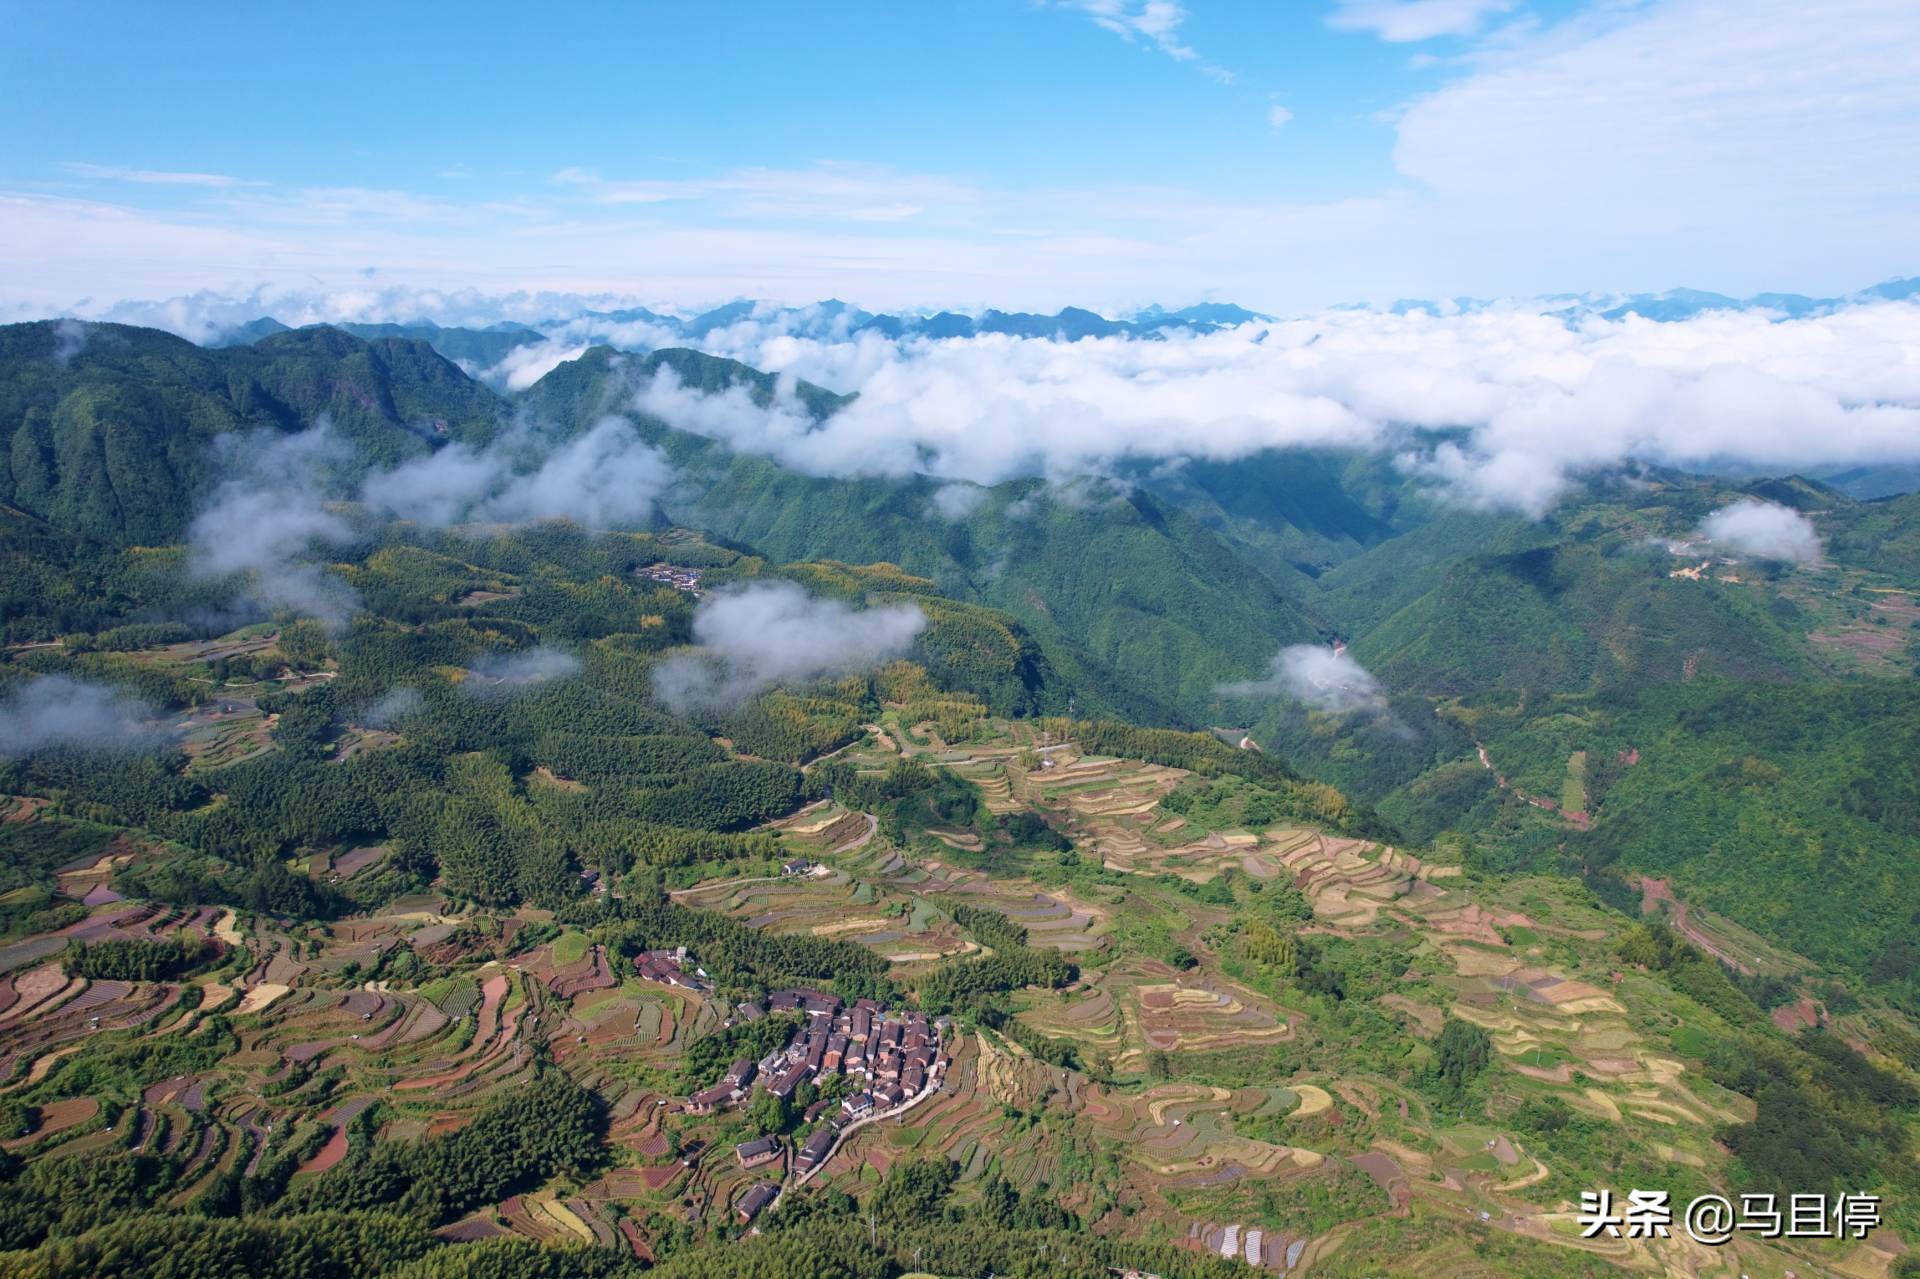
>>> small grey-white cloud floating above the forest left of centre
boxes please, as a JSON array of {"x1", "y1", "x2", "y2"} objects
[{"x1": 653, "y1": 582, "x2": 927, "y2": 714}]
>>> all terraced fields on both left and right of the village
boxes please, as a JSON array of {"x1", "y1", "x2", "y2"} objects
[{"x1": 0, "y1": 710, "x2": 1891, "y2": 1275}]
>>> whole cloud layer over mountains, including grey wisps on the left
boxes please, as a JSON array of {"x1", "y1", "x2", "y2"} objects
[{"x1": 139, "y1": 282, "x2": 1920, "y2": 524}]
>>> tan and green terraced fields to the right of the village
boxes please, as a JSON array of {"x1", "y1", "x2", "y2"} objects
[{"x1": 710, "y1": 734, "x2": 1891, "y2": 1273}]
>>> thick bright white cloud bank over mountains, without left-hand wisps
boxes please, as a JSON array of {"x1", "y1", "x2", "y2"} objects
[{"x1": 610, "y1": 302, "x2": 1920, "y2": 515}]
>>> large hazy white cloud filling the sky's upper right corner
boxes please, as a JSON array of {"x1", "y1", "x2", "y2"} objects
[{"x1": 1394, "y1": 0, "x2": 1920, "y2": 290}]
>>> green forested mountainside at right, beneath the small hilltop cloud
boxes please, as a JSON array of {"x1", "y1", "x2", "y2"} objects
[{"x1": 1227, "y1": 476, "x2": 1920, "y2": 1006}]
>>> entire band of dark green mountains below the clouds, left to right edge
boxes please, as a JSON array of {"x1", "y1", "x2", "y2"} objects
[{"x1": 0, "y1": 313, "x2": 1914, "y2": 706}]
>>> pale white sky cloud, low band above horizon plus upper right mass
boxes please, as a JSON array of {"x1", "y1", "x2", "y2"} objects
[{"x1": 15, "y1": 0, "x2": 1920, "y2": 319}]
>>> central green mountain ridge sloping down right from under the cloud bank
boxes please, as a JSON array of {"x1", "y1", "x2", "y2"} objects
[{"x1": 516, "y1": 350, "x2": 1336, "y2": 722}]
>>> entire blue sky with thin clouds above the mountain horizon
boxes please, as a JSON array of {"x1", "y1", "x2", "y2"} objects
[{"x1": 0, "y1": 0, "x2": 1920, "y2": 313}]
